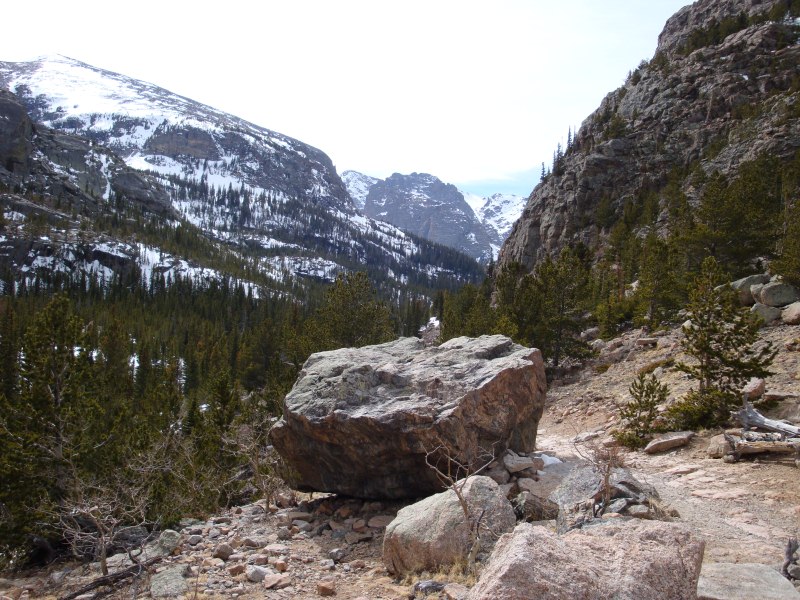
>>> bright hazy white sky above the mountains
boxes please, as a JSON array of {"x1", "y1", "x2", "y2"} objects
[{"x1": 0, "y1": 0, "x2": 690, "y2": 195}]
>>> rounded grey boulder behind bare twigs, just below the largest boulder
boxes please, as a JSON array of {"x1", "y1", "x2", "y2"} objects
[{"x1": 383, "y1": 475, "x2": 516, "y2": 576}]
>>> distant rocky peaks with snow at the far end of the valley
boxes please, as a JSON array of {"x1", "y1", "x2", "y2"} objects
[{"x1": 342, "y1": 171, "x2": 526, "y2": 262}]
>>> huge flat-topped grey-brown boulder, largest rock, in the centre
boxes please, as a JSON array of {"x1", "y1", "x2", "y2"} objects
[{"x1": 270, "y1": 335, "x2": 546, "y2": 498}]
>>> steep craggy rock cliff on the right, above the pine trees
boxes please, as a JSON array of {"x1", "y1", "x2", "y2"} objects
[{"x1": 499, "y1": 0, "x2": 800, "y2": 269}]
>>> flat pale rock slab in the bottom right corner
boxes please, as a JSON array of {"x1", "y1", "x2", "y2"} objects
[{"x1": 697, "y1": 563, "x2": 800, "y2": 600}]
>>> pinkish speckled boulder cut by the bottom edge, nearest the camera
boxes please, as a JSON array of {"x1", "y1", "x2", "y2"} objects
[{"x1": 467, "y1": 519, "x2": 704, "y2": 600}]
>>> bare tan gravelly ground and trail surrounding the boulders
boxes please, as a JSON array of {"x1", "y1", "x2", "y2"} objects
[{"x1": 0, "y1": 325, "x2": 800, "y2": 600}]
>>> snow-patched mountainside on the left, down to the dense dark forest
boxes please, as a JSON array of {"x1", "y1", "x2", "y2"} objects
[{"x1": 0, "y1": 56, "x2": 488, "y2": 295}]
